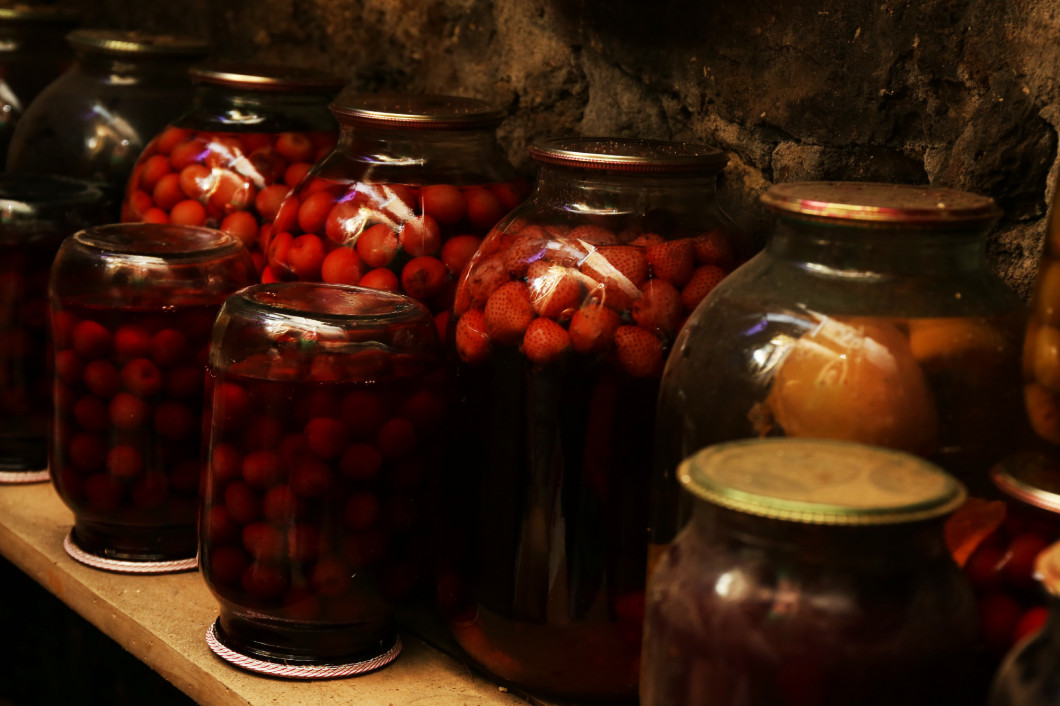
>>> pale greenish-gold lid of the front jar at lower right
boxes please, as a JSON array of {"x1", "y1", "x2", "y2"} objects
[{"x1": 677, "y1": 438, "x2": 967, "y2": 526}]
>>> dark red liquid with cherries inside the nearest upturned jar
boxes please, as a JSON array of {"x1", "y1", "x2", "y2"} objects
[{"x1": 200, "y1": 364, "x2": 442, "y2": 664}]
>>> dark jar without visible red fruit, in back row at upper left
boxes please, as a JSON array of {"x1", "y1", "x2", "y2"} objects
[{"x1": 6, "y1": 30, "x2": 209, "y2": 220}]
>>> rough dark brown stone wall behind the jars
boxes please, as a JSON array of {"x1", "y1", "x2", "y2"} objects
[{"x1": 72, "y1": 0, "x2": 1060, "y2": 295}]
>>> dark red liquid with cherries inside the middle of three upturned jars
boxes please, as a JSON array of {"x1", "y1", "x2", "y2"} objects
[{"x1": 51, "y1": 301, "x2": 219, "y2": 561}]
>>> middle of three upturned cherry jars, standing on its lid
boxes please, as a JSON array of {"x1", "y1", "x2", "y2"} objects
[{"x1": 50, "y1": 224, "x2": 254, "y2": 573}]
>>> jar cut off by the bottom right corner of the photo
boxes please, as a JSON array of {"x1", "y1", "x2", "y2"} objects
[{"x1": 987, "y1": 544, "x2": 1060, "y2": 706}]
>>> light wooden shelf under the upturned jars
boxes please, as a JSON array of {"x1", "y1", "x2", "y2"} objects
[{"x1": 0, "y1": 482, "x2": 543, "y2": 706}]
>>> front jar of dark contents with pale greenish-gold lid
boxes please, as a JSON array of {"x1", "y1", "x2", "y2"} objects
[{"x1": 640, "y1": 439, "x2": 977, "y2": 706}]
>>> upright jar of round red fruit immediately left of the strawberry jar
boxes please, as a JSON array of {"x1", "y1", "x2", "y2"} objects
[{"x1": 262, "y1": 94, "x2": 526, "y2": 316}]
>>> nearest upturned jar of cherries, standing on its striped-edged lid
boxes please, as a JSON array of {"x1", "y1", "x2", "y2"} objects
[{"x1": 199, "y1": 282, "x2": 444, "y2": 678}]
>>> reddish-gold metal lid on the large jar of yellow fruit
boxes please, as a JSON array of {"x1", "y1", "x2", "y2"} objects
[{"x1": 761, "y1": 181, "x2": 1001, "y2": 226}]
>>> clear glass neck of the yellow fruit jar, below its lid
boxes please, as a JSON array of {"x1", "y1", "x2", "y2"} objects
[{"x1": 765, "y1": 218, "x2": 987, "y2": 273}]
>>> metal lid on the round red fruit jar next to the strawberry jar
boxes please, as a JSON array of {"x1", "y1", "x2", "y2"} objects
[{"x1": 331, "y1": 93, "x2": 505, "y2": 130}]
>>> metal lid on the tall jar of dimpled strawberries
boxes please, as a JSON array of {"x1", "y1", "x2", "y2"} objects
[{"x1": 529, "y1": 138, "x2": 728, "y2": 175}]
